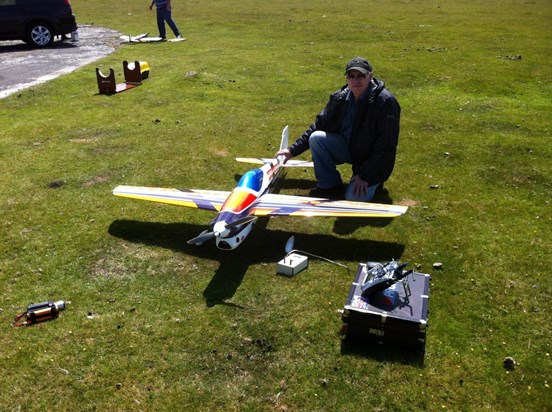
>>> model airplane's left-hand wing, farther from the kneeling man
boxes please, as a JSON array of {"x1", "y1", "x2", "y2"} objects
[{"x1": 113, "y1": 186, "x2": 230, "y2": 212}]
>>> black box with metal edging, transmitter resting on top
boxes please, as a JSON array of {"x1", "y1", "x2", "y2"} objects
[{"x1": 342, "y1": 263, "x2": 430, "y2": 351}]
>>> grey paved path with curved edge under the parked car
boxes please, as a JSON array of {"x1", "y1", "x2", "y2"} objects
[{"x1": 0, "y1": 24, "x2": 121, "y2": 99}]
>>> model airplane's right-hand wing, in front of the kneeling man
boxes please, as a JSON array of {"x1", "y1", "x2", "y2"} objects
[{"x1": 248, "y1": 193, "x2": 408, "y2": 218}]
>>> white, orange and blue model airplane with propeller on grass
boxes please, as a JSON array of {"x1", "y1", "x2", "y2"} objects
[{"x1": 113, "y1": 126, "x2": 408, "y2": 250}]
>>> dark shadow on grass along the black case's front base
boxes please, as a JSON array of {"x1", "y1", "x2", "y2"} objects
[{"x1": 341, "y1": 339, "x2": 425, "y2": 368}]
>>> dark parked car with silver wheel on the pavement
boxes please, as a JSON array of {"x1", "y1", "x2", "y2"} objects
[{"x1": 0, "y1": 0, "x2": 77, "y2": 47}]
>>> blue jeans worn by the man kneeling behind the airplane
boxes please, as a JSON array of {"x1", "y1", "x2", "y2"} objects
[{"x1": 309, "y1": 130, "x2": 379, "y2": 202}]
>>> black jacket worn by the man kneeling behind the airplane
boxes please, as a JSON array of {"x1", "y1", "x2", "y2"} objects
[{"x1": 289, "y1": 79, "x2": 401, "y2": 186}]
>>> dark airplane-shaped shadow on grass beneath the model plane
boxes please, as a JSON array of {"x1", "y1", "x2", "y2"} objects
[{"x1": 108, "y1": 218, "x2": 404, "y2": 307}]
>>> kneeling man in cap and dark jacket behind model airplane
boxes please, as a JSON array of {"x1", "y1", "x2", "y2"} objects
[{"x1": 276, "y1": 57, "x2": 401, "y2": 202}]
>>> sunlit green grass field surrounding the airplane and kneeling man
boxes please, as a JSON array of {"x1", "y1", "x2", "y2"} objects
[{"x1": 0, "y1": 0, "x2": 552, "y2": 411}]
